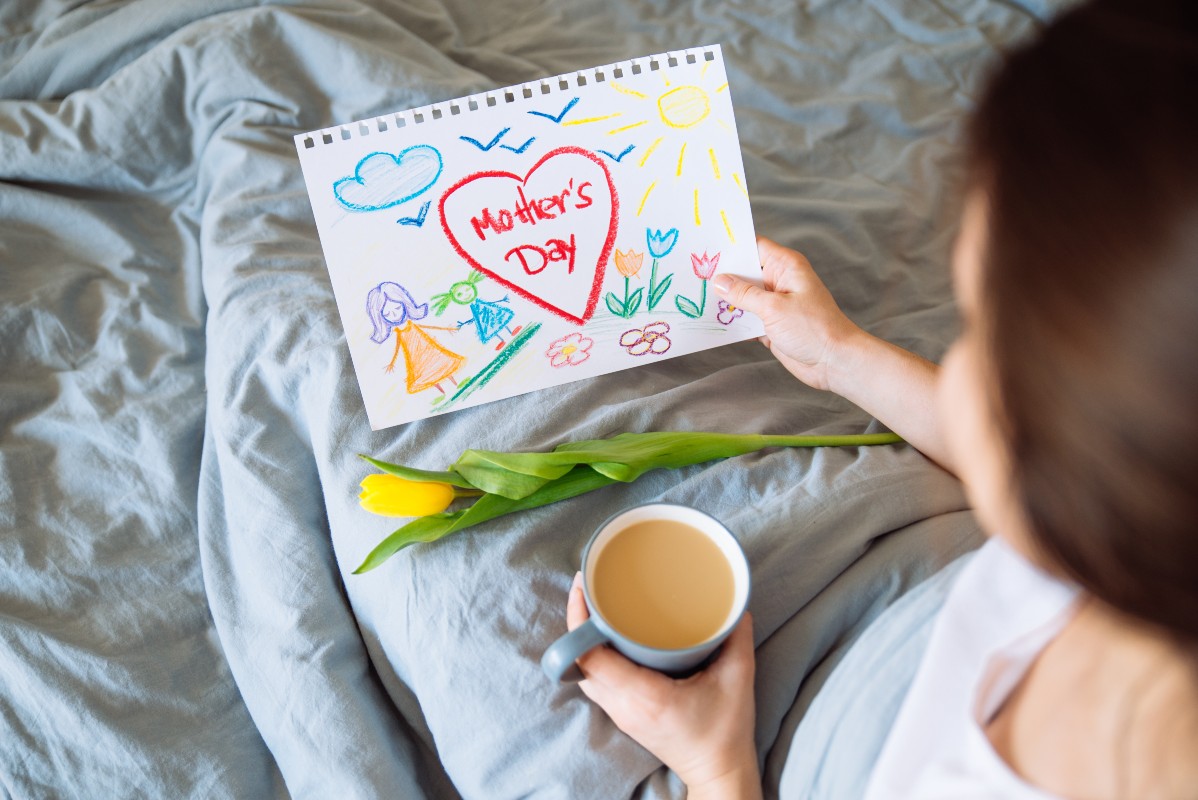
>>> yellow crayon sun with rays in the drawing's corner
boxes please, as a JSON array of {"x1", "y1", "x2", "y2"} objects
[{"x1": 562, "y1": 61, "x2": 748, "y2": 243}]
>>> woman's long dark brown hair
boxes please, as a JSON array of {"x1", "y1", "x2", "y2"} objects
[{"x1": 969, "y1": 0, "x2": 1198, "y2": 647}]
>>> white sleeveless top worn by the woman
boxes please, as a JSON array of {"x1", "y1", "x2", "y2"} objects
[{"x1": 865, "y1": 538, "x2": 1078, "y2": 800}]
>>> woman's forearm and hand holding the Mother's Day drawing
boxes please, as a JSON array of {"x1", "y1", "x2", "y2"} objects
[{"x1": 712, "y1": 238, "x2": 952, "y2": 472}]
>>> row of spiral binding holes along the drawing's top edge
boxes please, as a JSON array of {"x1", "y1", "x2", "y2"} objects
[{"x1": 301, "y1": 46, "x2": 715, "y2": 149}]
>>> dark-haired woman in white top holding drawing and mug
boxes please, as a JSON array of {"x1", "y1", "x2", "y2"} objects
[{"x1": 568, "y1": 1, "x2": 1198, "y2": 799}]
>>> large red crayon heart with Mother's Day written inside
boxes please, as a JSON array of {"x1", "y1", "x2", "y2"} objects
[{"x1": 438, "y1": 147, "x2": 619, "y2": 325}]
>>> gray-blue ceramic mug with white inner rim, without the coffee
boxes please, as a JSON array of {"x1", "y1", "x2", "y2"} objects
[{"x1": 540, "y1": 503, "x2": 750, "y2": 683}]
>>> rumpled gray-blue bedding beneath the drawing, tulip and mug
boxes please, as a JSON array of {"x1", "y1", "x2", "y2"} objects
[{"x1": 0, "y1": 0, "x2": 1068, "y2": 798}]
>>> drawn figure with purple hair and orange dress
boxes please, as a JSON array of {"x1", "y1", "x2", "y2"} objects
[{"x1": 367, "y1": 281, "x2": 465, "y2": 400}]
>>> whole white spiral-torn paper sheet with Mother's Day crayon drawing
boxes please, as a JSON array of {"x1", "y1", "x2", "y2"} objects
[{"x1": 296, "y1": 46, "x2": 762, "y2": 429}]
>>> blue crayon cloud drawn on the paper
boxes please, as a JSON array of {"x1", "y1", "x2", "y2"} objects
[{"x1": 333, "y1": 145, "x2": 443, "y2": 211}]
